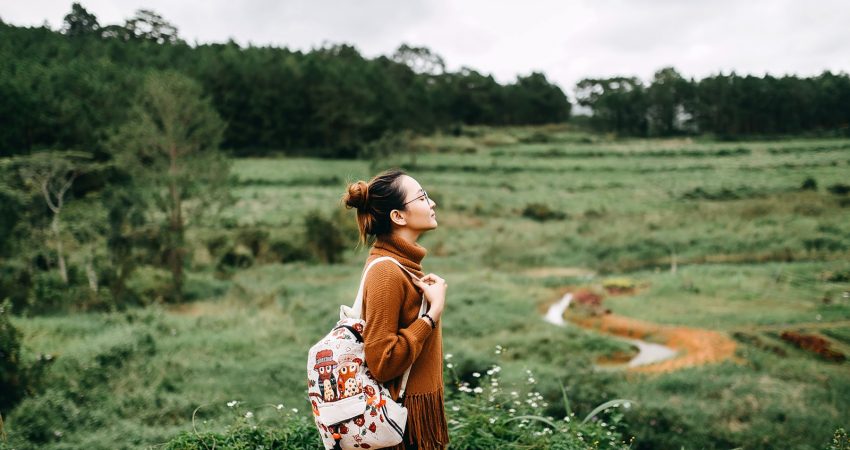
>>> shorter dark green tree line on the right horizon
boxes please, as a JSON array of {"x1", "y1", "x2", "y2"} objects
[{"x1": 575, "y1": 67, "x2": 850, "y2": 138}]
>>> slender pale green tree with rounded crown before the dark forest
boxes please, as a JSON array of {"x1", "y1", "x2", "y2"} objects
[{"x1": 110, "y1": 72, "x2": 229, "y2": 302}]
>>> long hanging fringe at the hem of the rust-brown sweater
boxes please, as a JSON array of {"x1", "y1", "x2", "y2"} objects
[{"x1": 404, "y1": 389, "x2": 449, "y2": 450}]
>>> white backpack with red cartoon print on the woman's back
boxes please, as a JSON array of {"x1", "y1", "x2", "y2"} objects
[{"x1": 307, "y1": 256, "x2": 426, "y2": 450}]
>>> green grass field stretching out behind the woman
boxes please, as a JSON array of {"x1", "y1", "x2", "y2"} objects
[{"x1": 4, "y1": 127, "x2": 850, "y2": 449}]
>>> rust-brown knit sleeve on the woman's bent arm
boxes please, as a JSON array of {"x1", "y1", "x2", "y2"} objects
[{"x1": 363, "y1": 261, "x2": 431, "y2": 382}]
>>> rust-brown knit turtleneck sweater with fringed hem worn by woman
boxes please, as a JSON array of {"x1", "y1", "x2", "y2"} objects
[{"x1": 363, "y1": 236, "x2": 449, "y2": 450}]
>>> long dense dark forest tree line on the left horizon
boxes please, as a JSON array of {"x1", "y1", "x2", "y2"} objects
[{"x1": 0, "y1": 3, "x2": 571, "y2": 157}]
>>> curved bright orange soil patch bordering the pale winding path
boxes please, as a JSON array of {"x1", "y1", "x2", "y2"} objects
[{"x1": 570, "y1": 314, "x2": 736, "y2": 373}]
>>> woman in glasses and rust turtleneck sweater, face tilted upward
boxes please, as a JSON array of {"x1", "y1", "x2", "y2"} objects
[{"x1": 343, "y1": 169, "x2": 449, "y2": 450}]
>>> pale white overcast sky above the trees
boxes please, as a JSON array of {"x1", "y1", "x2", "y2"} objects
[{"x1": 0, "y1": 0, "x2": 850, "y2": 94}]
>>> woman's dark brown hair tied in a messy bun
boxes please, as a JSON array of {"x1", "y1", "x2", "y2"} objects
[{"x1": 342, "y1": 169, "x2": 407, "y2": 244}]
